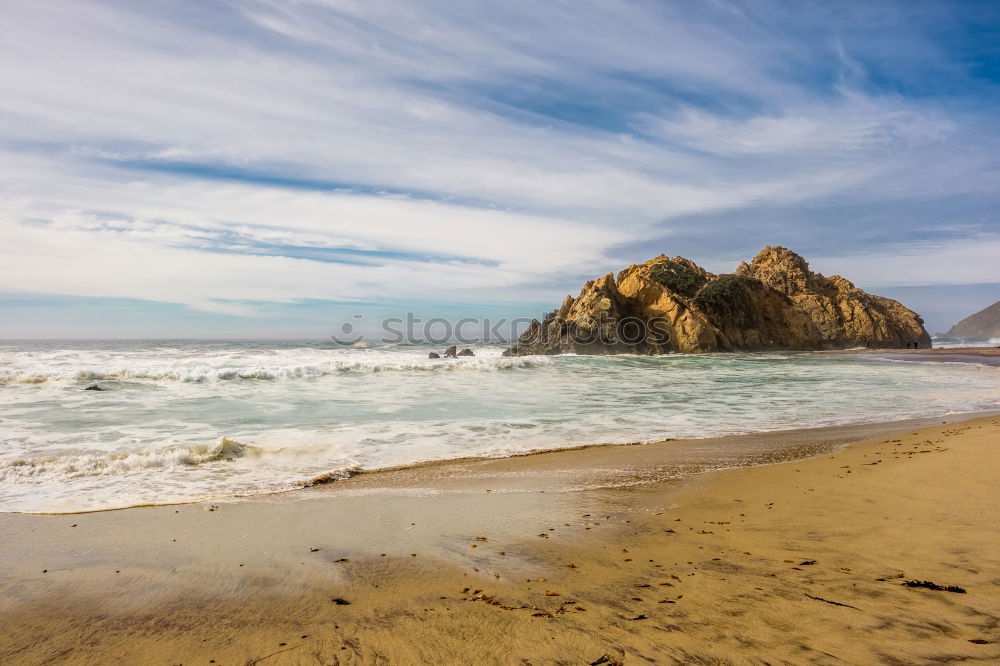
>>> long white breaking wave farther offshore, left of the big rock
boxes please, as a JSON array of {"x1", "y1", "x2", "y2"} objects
[{"x1": 0, "y1": 356, "x2": 552, "y2": 385}]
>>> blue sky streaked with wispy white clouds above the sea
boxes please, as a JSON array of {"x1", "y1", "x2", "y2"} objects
[{"x1": 0, "y1": 0, "x2": 1000, "y2": 338}]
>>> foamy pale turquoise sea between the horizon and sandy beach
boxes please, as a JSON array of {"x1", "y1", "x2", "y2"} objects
[{"x1": 0, "y1": 342, "x2": 1000, "y2": 511}]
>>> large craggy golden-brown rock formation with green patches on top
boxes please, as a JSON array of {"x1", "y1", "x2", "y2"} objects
[{"x1": 505, "y1": 246, "x2": 931, "y2": 355}]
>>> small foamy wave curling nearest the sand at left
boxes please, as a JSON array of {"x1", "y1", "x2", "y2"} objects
[{"x1": 0, "y1": 437, "x2": 263, "y2": 483}]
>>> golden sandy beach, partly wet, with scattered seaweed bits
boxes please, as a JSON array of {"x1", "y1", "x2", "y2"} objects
[{"x1": 0, "y1": 416, "x2": 1000, "y2": 664}]
